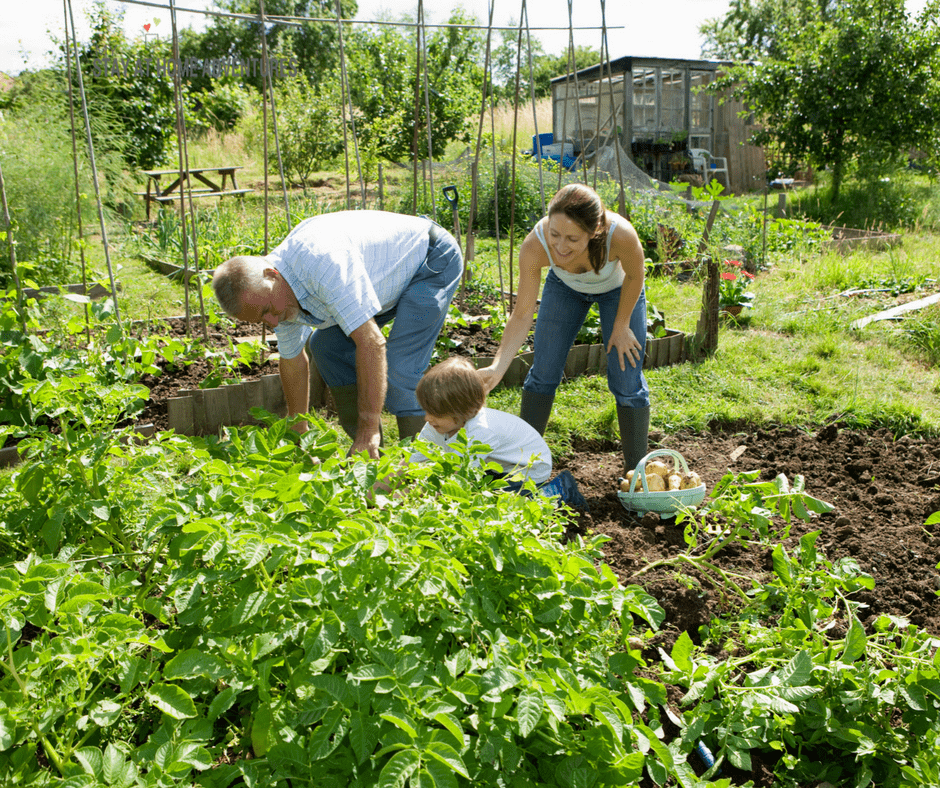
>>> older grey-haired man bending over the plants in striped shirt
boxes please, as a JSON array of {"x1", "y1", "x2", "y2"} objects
[{"x1": 212, "y1": 211, "x2": 463, "y2": 457}]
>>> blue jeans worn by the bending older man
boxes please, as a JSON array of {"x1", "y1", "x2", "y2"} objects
[{"x1": 307, "y1": 225, "x2": 463, "y2": 416}]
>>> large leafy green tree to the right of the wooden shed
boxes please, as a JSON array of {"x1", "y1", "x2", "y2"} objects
[{"x1": 713, "y1": 0, "x2": 940, "y2": 202}]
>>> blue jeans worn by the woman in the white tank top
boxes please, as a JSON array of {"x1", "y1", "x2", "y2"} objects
[{"x1": 522, "y1": 271, "x2": 650, "y2": 408}]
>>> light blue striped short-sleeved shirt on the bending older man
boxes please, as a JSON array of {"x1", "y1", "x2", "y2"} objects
[{"x1": 267, "y1": 211, "x2": 431, "y2": 358}]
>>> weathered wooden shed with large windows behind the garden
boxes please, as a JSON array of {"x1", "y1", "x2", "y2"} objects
[{"x1": 551, "y1": 57, "x2": 766, "y2": 193}]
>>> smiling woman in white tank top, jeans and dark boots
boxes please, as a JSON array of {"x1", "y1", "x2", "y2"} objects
[{"x1": 480, "y1": 183, "x2": 649, "y2": 470}]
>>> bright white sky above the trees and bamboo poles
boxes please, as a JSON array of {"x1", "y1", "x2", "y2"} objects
[{"x1": 0, "y1": 0, "x2": 926, "y2": 75}]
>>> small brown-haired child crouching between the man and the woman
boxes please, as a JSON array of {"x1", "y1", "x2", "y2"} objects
[{"x1": 411, "y1": 356, "x2": 587, "y2": 508}]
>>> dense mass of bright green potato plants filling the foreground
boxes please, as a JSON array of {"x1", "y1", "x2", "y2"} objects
[{"x1": 0, "y1": 422, "x2": 686, "y2": 786}]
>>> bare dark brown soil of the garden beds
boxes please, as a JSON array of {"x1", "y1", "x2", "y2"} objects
[{"x1": 134, "y1": 314, "x2": 940, "y2": 786}]
